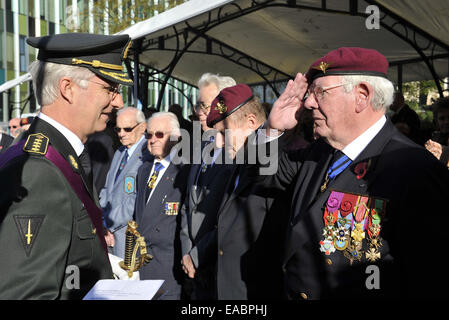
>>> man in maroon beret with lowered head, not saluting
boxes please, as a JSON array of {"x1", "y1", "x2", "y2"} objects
[{"x1": 201, "y1": 84, "x2": 285, "y2": 300}]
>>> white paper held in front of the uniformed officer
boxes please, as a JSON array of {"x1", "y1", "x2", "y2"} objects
[{"x1": 83, "y1": 279, "x2": 164, "y2": 300}]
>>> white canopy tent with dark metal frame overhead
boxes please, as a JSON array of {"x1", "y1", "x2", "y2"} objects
[{"x1": 120, "y1": 0, "x2": 449, "y2": 107}]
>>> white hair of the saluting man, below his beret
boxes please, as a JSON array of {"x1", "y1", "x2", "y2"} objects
[{"x1": 342, "y1": 75, "x2": 394, "y2": 111}]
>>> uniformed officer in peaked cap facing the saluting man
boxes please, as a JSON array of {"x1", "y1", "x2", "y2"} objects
[{"x1": 0, "y1": 33, "x2": 132, "y2": 300}]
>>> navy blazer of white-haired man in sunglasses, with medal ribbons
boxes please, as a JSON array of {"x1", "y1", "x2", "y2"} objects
[{"x1": 135, "y1": 157, "x2": 188, "y2": 299}]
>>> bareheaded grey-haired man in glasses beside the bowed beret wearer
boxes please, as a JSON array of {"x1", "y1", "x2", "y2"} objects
[{"x1": 180, "y1": 73, "x2": 236, "y2": 300}]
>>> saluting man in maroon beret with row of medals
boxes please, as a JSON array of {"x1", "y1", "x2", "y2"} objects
[{"x1": 265, "y1": 48, "x2": 449, "y2": 301}]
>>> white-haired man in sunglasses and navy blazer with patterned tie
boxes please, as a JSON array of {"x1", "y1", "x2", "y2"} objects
[{"x1": 135, "y1": 112, "x2": 188, "y2": 300}]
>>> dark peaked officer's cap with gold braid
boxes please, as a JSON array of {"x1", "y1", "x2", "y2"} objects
[{"x1": 27, "y1": 33, "x2": 133, "y2": 86}]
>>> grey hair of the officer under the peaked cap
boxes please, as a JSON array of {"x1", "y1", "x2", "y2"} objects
[{"x1": 28, "y1": 60, "x2": 95, "y2": 106}]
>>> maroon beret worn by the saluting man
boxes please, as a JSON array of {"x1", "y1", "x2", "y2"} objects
[{"x1": 306, "y1": 47, "x2": 388, "y2": 83}]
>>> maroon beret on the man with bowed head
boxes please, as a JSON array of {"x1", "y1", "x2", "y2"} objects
[{"x1": 207, "y1": 83, "x2": 254, "y2": 128}]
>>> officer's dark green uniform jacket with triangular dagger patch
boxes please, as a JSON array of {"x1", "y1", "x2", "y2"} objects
[{"x1": 0, "y1": 118, "x2": 112, "y2": 299}]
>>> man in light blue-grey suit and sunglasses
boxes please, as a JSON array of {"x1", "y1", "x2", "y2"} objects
[{"x1": 100, "y1": 107, "x2": 147, "y2": 259}]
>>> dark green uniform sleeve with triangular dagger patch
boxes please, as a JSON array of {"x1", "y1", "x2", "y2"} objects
[{"x1": 0, "y1": 158, "x2": 76, "y2": 299}]
